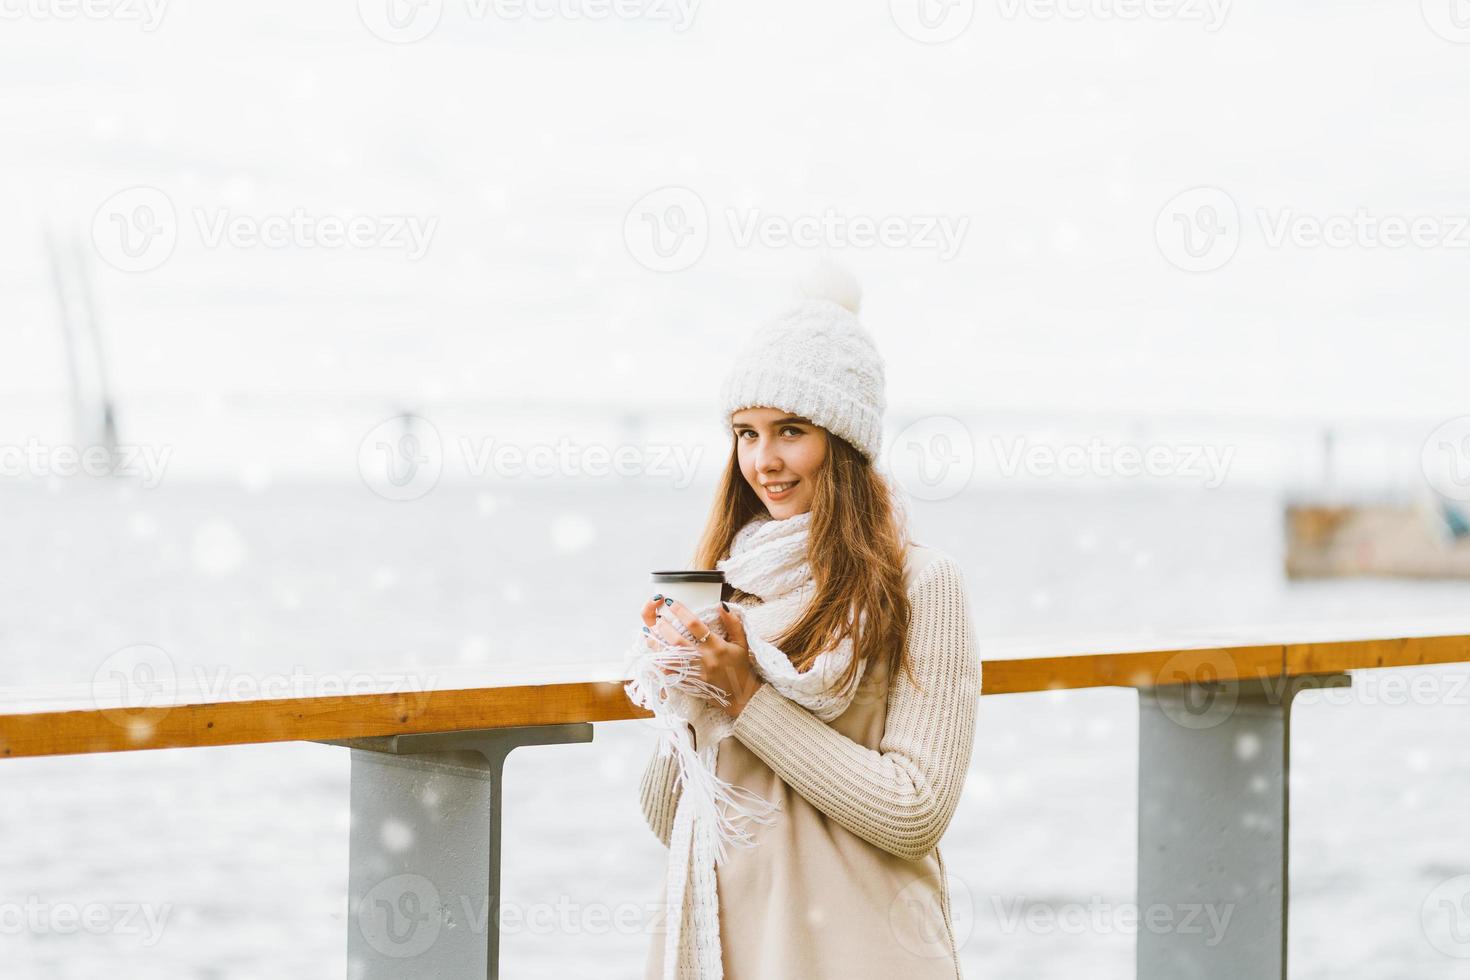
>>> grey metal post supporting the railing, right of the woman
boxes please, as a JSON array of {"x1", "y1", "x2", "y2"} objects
[{"x1": 1138, "y1": 674, "x2": 1351, "y2": 980}]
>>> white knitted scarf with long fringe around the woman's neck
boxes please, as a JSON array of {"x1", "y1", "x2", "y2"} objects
[{"x1": 623, "y1": 511, "x2": 863, "y2": 980}]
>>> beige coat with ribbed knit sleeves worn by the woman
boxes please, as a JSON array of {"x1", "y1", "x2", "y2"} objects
[{"x1": 641, "y1": 545, "x2": 980, "y2": 980}]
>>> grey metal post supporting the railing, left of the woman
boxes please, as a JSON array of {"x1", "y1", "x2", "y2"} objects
[{"x1": 326, "y1": 721, "x2": 592, "y2": 980}]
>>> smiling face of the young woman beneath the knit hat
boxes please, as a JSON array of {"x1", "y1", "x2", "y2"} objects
[{"x1": 731, "y1": 408, "x2": 826, "y2": 520}]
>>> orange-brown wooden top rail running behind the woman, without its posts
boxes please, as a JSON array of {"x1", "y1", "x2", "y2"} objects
[{"x1": 0, "y1": 617, "x2": 1470, "y2": 758}]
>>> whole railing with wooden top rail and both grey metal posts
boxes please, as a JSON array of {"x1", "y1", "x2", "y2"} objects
[{"x1": 0, "y1": 617, "x2": 1470, "y2": 980}]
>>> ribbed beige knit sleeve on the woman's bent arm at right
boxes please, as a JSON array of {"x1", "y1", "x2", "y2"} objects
[{"x1": 734, "y1": 554, "x2": 980, "y2": 861}]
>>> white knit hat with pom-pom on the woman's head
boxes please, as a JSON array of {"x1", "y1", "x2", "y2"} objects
[{"x1": 720, "y1": 264, "x2": 886, "y2": 463}]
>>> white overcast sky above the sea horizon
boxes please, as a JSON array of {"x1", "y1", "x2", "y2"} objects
[{"x1": 0, "y1": 0, "x2": 1470, "y2": 435}]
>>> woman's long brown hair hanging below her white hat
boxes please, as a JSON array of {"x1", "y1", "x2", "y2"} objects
[{"x1": 694, "y1": 430, "x2": 913, "y2": 691}]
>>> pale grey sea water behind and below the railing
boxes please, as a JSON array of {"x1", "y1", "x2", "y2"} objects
[{"x1": 0, "y1": 480, "x2": 1470, "y2": 980}]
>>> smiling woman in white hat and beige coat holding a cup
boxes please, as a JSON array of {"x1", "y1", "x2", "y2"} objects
[{"x1": 629, "y1": 268, "x2": 980, "y2": 980}]
